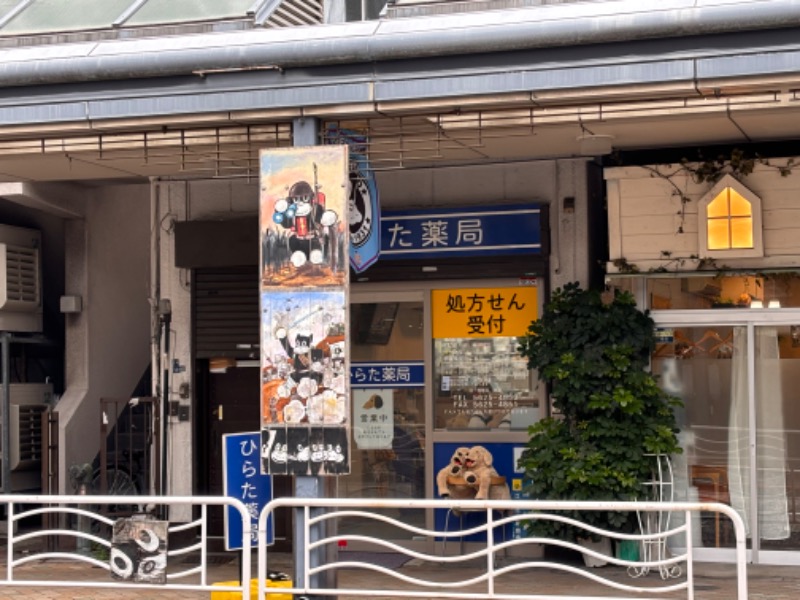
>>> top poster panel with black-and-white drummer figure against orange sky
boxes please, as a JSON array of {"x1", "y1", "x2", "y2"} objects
[{"x1": 259, "y1": 145, "x2": 349, "y2": 289}]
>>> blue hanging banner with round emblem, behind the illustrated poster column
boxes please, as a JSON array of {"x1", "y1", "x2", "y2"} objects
[{"x1": 328, "y1": 126, "x2": 381, "y2": 273}]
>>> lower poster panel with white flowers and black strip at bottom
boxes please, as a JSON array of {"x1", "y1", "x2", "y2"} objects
[{"x1": 261, "y1": 289, "x2": 350, "y2": 475}]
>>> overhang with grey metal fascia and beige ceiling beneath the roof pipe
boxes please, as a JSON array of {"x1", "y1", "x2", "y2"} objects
[{"x1": 0, "y1": 0, "x2": 800, "y2": 182}]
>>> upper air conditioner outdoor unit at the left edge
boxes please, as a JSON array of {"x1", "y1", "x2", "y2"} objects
[{"x1": 0, "y1": 225, "x2": 42, "y2": 332}]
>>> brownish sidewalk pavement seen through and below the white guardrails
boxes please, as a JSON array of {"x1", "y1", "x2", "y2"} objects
[{"x1": 0, "y1": 553, "x2": 800, "y2": 600}]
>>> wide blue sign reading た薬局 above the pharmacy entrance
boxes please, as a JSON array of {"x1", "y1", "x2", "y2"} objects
[{"x1": 381, "y1": 204, "x2": 542, "y2": 260}]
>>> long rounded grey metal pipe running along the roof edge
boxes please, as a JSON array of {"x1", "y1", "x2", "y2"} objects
[{"x1": 0, "y1": 0, "x2": 800, "y2": 87}]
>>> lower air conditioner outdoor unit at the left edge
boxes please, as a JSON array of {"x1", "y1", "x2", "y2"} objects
[{"x1": 0, "y1": 383, "x2": 53, "y2": 491}]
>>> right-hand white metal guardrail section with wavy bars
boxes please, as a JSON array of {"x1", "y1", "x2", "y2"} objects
[{"x1": 258, "y1": 498, "x2": 747, "y2": 600}]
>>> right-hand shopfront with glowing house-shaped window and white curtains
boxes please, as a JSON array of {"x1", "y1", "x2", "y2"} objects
[{"x1": 606, "y1": 157, "x2": 800, "y2": 564}]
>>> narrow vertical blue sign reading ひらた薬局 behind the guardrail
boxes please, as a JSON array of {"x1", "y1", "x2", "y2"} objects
[{"x1": 222, "y1": 432, "x2": 275, "y2": 550}]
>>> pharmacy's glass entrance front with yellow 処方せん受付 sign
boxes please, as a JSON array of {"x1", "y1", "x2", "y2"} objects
[{"x1": 337, "y1": 279, "x2": 544, "y2": 544}]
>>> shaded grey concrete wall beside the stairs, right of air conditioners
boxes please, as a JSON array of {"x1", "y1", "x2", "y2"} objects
[{"x1": 57, "y1": 184, "x2": 150, "y2": 492}]
